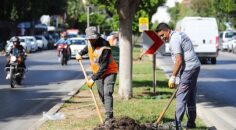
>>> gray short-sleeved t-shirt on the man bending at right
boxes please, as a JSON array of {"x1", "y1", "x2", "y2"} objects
[{"x1": 169, "y1": 31, "x2": 201, "y2": 70}]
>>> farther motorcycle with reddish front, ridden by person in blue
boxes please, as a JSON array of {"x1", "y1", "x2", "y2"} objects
[{"x1": 57, "y1": 43, "x2": 70, "y2": 65}]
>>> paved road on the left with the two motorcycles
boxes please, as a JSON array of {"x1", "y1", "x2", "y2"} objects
[{"x1": 0, "y1": 50, "x2": 88, "y2": 130}]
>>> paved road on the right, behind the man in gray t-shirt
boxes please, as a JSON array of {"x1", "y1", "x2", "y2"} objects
[{"x1": 157, "y1": 52, "x2": 236, "y2": 130}]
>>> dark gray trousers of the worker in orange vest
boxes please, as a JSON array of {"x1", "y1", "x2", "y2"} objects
[{"x1": 96, "y1": 74, "x2": 116, "y2": 120}]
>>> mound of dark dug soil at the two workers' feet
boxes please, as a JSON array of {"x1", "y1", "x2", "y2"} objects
[{"x1": 94, "y1": 117, "x2": 173, "y2": 130}]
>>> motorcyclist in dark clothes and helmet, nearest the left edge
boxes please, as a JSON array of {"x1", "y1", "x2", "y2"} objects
[{"x1": 5, "y1": 36, "x2": 26, "y2": 79}]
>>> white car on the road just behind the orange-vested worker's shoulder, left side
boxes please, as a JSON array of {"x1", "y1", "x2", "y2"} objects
[{"x1": 69, "y1": 37, "x2": 88, "y2": 58}]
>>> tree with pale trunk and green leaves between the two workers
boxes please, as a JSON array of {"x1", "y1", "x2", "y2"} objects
[{"x1": 86, "y1": 0, "x2": 164, "y2": 99}]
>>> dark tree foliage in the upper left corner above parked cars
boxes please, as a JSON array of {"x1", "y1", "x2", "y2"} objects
[{"x1": 0, "y1": 0, "x2": 66, "y2": 22}]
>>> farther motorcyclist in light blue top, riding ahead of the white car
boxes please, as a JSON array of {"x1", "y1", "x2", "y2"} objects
[{"x1": 54, "y1": 31, "x2": 70, "y2": 57}]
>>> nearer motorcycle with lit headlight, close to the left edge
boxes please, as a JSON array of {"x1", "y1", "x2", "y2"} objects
[{"x1": 6, "y1": 50, "x2": 25, "y2": 88}]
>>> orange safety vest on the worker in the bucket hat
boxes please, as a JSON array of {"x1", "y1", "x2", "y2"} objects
[{"x1": 88, "y1": 43, "x2": 118, "y2": 77}]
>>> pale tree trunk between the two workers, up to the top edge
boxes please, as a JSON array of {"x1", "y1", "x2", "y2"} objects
[{"x1": 117, "y1": 0, "x2": 139, "y2": 100}]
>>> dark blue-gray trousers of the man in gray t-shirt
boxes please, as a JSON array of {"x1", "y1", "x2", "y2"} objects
[{"x1": 176, "y1": 67, "x2": 200, "y2": 126}]
